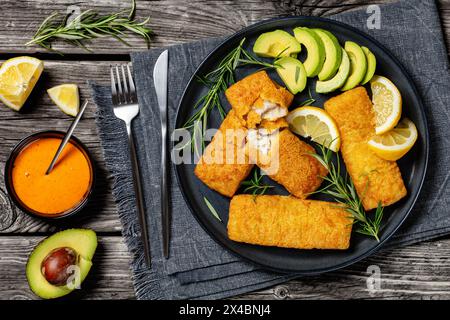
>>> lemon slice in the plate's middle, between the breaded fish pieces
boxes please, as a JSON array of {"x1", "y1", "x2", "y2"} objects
[{"x1": 286, "y1": 106, "x2": 341, "y2": 152}]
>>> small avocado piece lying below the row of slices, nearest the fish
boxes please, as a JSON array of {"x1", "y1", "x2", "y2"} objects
[{"x1": 276, "y1": 57, "x2": 307, "y2": 94}]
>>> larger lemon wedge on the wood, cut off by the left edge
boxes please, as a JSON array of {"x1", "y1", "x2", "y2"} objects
[{"x1": 0, "y1": 56, "x2": 44, "y2": 111}]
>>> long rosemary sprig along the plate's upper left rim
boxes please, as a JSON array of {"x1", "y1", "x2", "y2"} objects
[{"x1": 183, "y1": 38, "x2": 277, "y2": 155}]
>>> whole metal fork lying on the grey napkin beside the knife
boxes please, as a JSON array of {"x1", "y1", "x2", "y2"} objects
[{"x1": 111, "y1": 64, "x2": 151, "y2": 267}]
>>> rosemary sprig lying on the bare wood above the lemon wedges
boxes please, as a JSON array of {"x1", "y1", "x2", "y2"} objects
[{"x1": 25, "y1": 0, "x2": 152, "y2": 51}]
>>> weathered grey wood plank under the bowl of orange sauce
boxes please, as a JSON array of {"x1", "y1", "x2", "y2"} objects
[{"x1": 0, "y1": 113, "x2": 121, "y2": 233}]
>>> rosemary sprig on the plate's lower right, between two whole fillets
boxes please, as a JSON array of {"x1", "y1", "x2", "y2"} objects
[{"x1": 311, "y1": 144, "x2": 383, "y2": 242}]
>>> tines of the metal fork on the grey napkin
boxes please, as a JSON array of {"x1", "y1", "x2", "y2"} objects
[{"x1": 111, "y1": 63, "x2": 137, "y2": 105}]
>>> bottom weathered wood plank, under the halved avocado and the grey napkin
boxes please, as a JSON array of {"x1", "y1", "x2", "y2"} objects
[{"x1": 0, "y1": 236, "x2": 450, "y2": 299}]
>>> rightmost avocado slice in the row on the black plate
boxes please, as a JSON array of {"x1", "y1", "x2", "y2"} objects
[{"x1": 341, "y1": 41, "x2": 367, "y2": 91}]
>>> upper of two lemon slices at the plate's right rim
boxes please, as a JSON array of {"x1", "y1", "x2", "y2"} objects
[{"x1": 370, "y1": 76, "x2": 402, "y2": 134}]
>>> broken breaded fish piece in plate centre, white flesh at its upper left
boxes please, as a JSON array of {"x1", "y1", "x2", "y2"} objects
[{"x1": 247, "y1": 129, "x2": 327, "y2": 199}]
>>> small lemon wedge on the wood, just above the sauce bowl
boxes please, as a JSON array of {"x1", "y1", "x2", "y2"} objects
[{"x1": 47, "y1": 83, "x2": 80, "y2": 117}]
